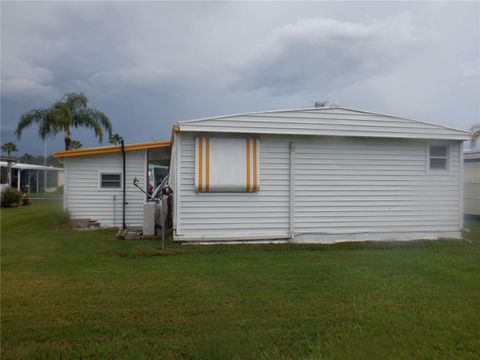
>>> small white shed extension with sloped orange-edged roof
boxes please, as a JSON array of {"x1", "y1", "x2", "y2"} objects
[{"x1": 55, "y1": 141, "x2": 170, "y2": 227}]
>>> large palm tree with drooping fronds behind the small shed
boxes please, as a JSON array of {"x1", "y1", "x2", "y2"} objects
[{"x1": 15, "y1": 93, "x2": 112, "y2": 150}]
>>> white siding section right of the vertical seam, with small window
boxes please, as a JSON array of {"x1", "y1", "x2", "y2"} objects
[{"x1": 294, "y1": 138, "x2": 460, "y2": 234}]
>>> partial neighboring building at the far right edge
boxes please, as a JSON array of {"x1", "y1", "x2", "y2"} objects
[{"x1": 463, "y1": 150, "x2": 480, "y2": 216}]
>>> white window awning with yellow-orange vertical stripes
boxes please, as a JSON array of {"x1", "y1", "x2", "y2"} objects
[{"x1": 195, "y1": 137, "x2": 260, "y2": 192}]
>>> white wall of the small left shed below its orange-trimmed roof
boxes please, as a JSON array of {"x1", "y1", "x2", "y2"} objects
[{"x1": 64, "y1": 150, "x2": 146, "y2": 227}]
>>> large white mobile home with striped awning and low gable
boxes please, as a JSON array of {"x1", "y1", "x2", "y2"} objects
[{"x1": 169, "y1": 108, "x2": 468, "y2": 242}]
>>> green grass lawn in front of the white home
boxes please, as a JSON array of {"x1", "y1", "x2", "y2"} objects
[{"x1": 1, "y1": 202, "x2": 480, "y2": 359}]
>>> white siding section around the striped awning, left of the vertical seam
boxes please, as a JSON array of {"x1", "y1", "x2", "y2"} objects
[{"x1": 177, "y1": 134, "x2": 290, "y2": 239}]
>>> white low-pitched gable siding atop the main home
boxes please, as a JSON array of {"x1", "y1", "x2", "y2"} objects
[{"x1": 180, "y1": 108, "x2": 468, "y2": 140}]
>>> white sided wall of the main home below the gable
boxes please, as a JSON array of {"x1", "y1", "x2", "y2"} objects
[{"x1": 174, "y1": 133, "x2": 463, "y2": 242}]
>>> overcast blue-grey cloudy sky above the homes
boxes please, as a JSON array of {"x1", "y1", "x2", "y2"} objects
[{"x1": 1, "y1": 1, "x2": 480, "y2": 155}]
